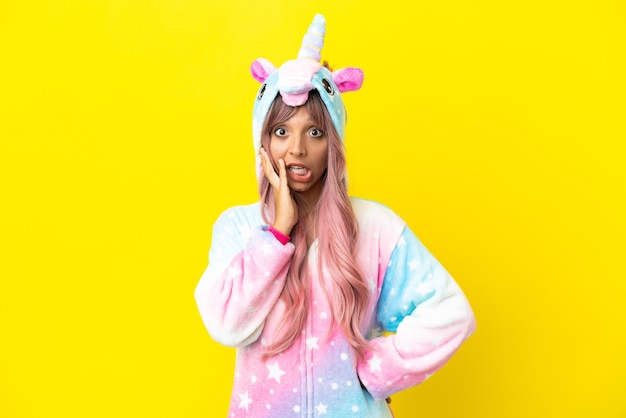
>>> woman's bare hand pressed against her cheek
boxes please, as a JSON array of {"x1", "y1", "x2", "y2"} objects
[{"x1": 259, "y1": 147, "x2": 298, "y2": 236}]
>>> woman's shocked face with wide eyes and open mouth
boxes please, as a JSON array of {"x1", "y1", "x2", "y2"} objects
[{"x1": 270, "y1": 106, "x2": 328, "y2": 202}]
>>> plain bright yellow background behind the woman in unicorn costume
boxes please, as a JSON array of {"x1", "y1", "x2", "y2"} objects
[{"x1": 0, "y1": 0, "x2": 626, "y2": 418}]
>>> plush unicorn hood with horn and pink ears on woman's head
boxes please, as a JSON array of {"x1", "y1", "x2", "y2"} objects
[{"x1": 250, "y1": 14, "x2": 363, "y2": 153}]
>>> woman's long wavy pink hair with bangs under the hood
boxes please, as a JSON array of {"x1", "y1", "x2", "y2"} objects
[{"x1": 259, "y1": 90, "x2": 369, "y2": 357}]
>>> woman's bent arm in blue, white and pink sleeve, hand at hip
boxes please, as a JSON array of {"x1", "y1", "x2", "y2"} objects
[{"x1": 357, "y1": 227, "x2": 475, "y2": 399}]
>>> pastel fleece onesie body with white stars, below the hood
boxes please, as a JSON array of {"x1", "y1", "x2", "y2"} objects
[{"x1": 195, "y1": 198, "x2": 475, "y2": 418}]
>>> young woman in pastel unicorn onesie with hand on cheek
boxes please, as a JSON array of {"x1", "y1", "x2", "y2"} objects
[{"x1": 195, "y1": 15, "x2": 475, "y2": 417}]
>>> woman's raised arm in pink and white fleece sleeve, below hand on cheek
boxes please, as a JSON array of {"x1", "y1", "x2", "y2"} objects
[{"x1": 195, "y1": 208, "x2": 294, "y2": 347}]
